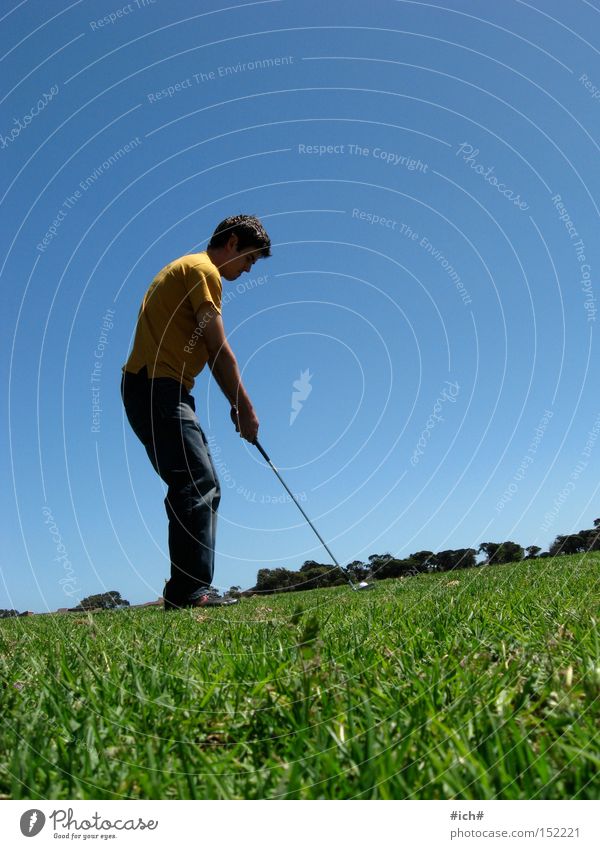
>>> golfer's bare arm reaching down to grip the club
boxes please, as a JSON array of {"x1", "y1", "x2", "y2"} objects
[{"x1": 196, "y1": 303, "x2": 258, "y2": 442}]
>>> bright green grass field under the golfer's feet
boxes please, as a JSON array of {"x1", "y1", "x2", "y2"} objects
[{"x1": 0, "y1": 553, "x2": 600, "y2": 799}]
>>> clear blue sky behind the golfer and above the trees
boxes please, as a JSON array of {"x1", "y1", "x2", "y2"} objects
[{"x1": 0, "y1": 0, "x2": 600, "y2": 610}]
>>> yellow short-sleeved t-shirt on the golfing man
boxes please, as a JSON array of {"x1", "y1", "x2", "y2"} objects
[{"x1": 122, "y1": 251, "x2": 222, "y2": 392}]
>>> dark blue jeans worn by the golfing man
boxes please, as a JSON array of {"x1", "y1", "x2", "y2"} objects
[{"x1": 121, "y1": 368, "x2": 221, "y2": 609}]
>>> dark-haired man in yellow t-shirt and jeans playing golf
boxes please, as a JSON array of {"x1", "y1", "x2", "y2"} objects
[{"x1": 121, "y1": 215, "x2": 271, "y2": 610}]
